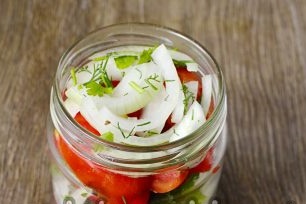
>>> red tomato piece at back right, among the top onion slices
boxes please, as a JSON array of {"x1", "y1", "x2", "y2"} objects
[{"x1": 176, "y1": 67, "x2": 202, "y2": 100}]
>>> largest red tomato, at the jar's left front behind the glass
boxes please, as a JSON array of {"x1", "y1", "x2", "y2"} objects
[{"x1": 56, "y1": 114, "x2": 151, "y2": 197}]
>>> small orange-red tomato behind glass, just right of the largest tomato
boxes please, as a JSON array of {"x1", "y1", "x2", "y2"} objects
[{"x1": 151, "y1": 170, "x2": 189, "y2": 193}]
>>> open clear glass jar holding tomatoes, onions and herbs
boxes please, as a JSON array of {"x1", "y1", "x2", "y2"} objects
[{"x1": 48, "y1": 23, "x2": 227, "y2": 204}]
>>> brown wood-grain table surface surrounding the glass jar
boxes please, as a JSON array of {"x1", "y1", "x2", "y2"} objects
[{"x1": 0, "y1": 0, "x2": 306, "y2": 204}]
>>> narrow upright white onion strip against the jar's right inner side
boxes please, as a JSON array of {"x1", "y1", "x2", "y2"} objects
[{"x1": 201, "y1": 75, "x2": 212, "y2": 115}]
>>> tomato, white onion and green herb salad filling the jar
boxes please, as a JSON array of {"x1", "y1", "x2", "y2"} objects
[{"x1": 48, "y1": 24, "x2": 226, "y2": 204}]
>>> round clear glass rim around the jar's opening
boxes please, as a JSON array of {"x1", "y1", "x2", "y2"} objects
[{"x1": 54, "y1": 22, "x2": 226, "y2": 155}]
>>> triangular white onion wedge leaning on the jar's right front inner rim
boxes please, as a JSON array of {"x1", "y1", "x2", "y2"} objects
[{"x1": 169, "y1": 100, "x2": 206, "y2": 142}]
